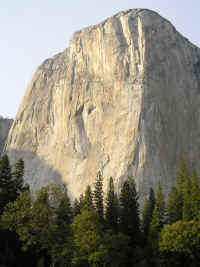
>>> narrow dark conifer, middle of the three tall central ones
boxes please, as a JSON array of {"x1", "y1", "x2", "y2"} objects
[{"x1": 105, "y1": 177, "x2": 119, "y2": 232}]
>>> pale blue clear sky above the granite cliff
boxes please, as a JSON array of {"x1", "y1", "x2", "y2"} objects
[{"x1": 0, "y1": 0, "x2": 200, "y2": 118}]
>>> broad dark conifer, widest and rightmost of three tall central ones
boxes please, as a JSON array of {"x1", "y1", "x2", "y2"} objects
[{"x1": 120, "y1": 178, "x2": 141, "y2": 246}]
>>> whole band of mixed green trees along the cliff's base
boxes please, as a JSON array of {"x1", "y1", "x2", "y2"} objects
[{"x1": 0, "y1": 155, "x2": 200, "y2": 267}]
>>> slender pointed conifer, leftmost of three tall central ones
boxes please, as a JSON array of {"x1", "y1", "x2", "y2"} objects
[{"x1": 94, "y1": 172, "x2": 104, "y2": 221}]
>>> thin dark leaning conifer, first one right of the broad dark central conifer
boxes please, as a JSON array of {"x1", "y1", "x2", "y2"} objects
[{"x1": 142, "y1": 188, "x2": 155, "y2": 240}]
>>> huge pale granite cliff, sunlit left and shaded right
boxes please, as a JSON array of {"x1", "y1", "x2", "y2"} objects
[{"x1": 6, "y1": 9, "x2": 200, "y2": 197}]
